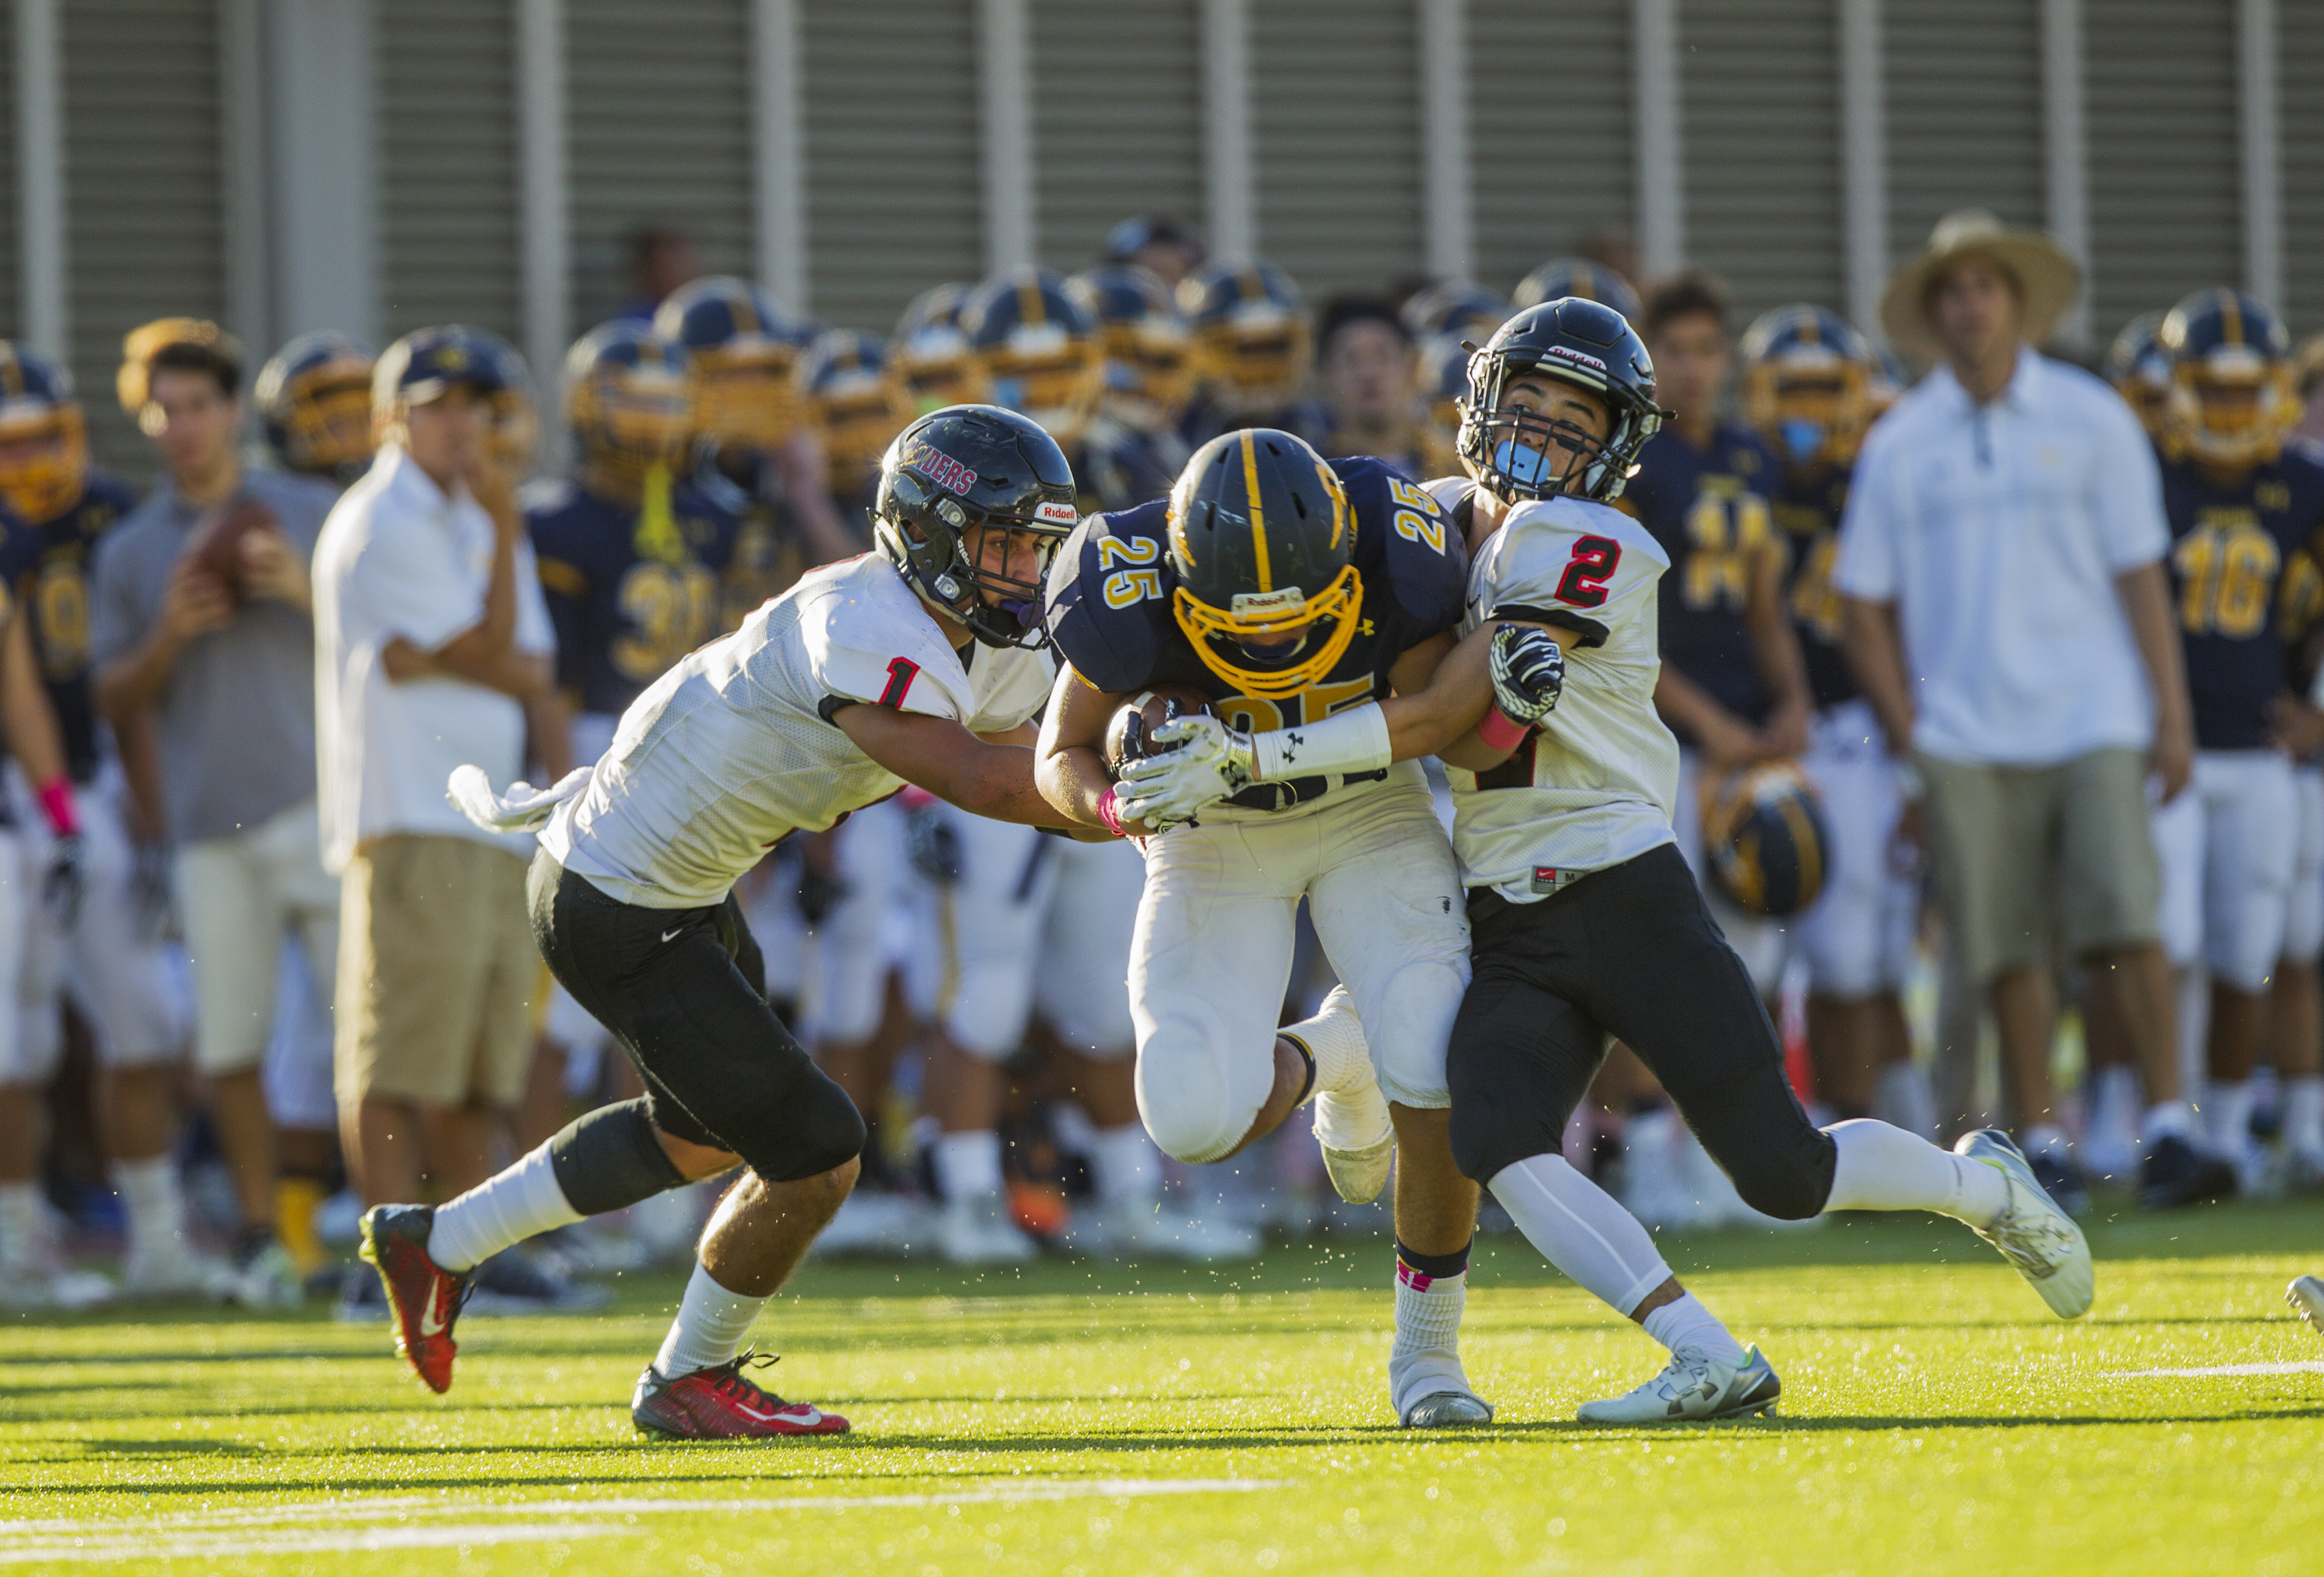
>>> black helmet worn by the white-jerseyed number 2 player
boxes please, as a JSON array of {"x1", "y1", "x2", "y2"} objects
[{"x1": 1457, "y1": 295, "x2": 1667, "y2": 504}]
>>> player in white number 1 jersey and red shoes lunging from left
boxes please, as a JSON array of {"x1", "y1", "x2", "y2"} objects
[{"x1": 363, "y1": 407, "x2": 1097, "y2": 1440}]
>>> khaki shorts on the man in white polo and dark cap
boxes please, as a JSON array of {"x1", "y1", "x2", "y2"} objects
[{"x1": 332, "y1": 834, "x2": 541, "y2": 1106}]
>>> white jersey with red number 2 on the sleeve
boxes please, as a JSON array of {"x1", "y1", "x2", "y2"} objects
[{"x1": 1429, "y1": 478, "x2": 1678, "y2": 904}]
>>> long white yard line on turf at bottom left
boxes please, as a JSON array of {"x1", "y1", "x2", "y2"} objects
[{"x1": 0, "y1": 1479, "x2": 1292, "y2": 1565}]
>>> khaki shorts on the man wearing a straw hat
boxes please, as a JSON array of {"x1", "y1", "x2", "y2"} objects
[{"x1": 1917, "y1": 750, "x2": 2161, "y2": 984}]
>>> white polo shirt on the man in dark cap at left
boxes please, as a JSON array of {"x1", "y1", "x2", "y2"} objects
[{"x1": 314, "y1": 443, "x2": 555, "y2": 873}]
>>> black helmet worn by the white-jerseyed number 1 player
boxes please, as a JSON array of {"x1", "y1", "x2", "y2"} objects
[{"x1": 871, "y1": 404, "x2": 1081, "y2": 651}]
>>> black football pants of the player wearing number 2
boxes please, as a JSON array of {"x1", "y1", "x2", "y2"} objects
[{"x1": 1446, "y1": 843, "x2": 1836, "y2": 1219}]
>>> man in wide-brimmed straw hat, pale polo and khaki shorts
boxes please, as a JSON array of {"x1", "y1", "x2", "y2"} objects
[{"x1": 1834, "y1": 209, "x2": 2233, "y2": 1205}]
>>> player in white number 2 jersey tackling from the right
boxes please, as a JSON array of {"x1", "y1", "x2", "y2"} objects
[{"x1": 1125, "y1": 297, "x2": 2092, "y2": 1424}]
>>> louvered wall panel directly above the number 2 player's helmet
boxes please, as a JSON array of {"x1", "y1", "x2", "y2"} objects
[{"x1": 1469, "y1": 0, "x2": 1636, "y2": 301}]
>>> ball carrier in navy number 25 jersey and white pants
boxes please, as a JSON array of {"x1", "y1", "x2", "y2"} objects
[{"x1": 1037, "y1": 427, "x2": 1492, "y2": 1426}]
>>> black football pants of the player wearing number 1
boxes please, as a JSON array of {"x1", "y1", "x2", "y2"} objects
[{"x1": 528, "y1": 850, "x2": 865, "y2": 1182}]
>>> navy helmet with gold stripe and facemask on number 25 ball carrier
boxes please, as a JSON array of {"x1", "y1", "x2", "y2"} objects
[{"x1": 1169, "y1": 427, "x2": 1364, "y2": 696}]
